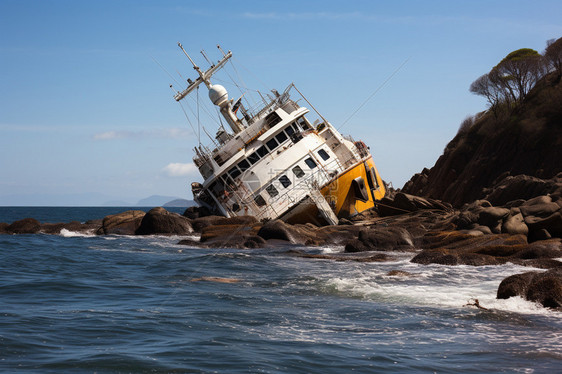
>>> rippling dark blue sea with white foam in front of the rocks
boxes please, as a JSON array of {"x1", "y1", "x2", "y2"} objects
[{"x1": 0, "y1": 207, "x2": 562, "y2": 374}]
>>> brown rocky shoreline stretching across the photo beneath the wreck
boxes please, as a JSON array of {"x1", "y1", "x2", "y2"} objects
[{"x1": 0, "y1": 173, "x2": 562, "y2": 311}]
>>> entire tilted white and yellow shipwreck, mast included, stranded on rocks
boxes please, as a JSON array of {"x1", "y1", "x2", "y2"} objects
[{"x1": 174, "y1": 44, "x2": 385, "y2": 224}]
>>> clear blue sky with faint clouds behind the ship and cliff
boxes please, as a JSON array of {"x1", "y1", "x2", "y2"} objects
[{"x1": 0, "y1": 0, "x2": 562, "y2": 205}]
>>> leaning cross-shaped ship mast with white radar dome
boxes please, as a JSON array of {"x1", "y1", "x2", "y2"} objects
[{"x1": 174, "y1": 43, "x2": 244, "y2": 134}]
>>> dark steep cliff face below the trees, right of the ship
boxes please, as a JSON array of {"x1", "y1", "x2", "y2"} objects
[{"x1": 402, "y1": 76, "x2": 562, "y2": 207}]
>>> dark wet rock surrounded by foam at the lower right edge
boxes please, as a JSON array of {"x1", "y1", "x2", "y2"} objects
[{"x1": 497, "y1": 268, "x2": 562, "y2": 309}]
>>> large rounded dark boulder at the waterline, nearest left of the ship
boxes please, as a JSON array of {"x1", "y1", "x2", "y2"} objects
[{"x1": 135, "y1": 207, "x2": 193, "y2": 235}]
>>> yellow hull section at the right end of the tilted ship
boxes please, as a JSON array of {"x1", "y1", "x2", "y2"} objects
[{"x1": 320, "y1": 157, "x2": 386, "y2": 218}]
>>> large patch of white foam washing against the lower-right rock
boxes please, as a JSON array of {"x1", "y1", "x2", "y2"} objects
[{"x1": 324, "y1": 261, "x2": 553, "y2": 315}]
